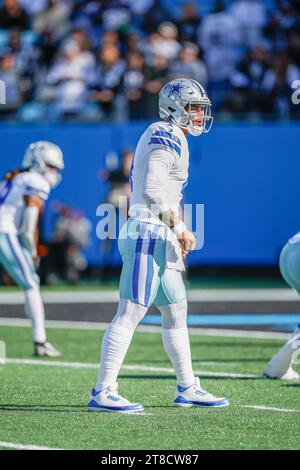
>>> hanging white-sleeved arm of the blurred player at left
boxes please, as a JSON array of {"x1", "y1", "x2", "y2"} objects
[{"x1": 20, "y1": 196, "x2": 44, "y2": 258}]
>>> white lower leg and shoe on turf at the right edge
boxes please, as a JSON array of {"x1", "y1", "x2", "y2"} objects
[{"x1": 264, "y1": 325, "x2": 300, "y2": 380}]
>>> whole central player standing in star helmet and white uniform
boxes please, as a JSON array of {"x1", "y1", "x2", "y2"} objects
[{"x1": 88, "y1": 79, "x2": 229, "y2": 412}]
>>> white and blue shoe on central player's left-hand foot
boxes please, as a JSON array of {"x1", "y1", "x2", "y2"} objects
[{"x1": 88, "y1": 384, "x2": 144, "y2": 413}]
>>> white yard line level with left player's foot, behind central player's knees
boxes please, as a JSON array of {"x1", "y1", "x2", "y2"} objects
[{"x1": 0, "y1": 317, "x2": 291, "y2": 340}]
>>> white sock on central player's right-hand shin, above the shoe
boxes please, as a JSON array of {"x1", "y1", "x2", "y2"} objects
[{"x1": 162, "y1": 327, "x2": 195, "y2": 387}]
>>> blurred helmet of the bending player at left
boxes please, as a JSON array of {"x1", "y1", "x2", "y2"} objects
[{"x1": 22, "y1": 140, "x2": 64, "y2": 188}]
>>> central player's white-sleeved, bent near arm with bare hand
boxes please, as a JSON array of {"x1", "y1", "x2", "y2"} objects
[{"x1": 143, "y1": 149, "x2": 196, "y2": 255}]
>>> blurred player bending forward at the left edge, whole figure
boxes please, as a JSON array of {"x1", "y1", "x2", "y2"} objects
[{"x1": 0, "y1": 141, "x2": 64, "y2": 357}]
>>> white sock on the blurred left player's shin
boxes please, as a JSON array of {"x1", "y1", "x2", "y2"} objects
[{"x1": 24, "y1": 286, "x2": 46, "y2": 343}]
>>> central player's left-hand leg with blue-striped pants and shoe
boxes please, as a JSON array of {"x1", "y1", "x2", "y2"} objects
[{"x1": 89, "y1": 224, "x2": 159, "y2": 411}]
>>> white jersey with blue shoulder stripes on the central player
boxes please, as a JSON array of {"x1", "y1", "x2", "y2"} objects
[{"x1": 129, "y1": 121, "x2": 189, "y2": 225}]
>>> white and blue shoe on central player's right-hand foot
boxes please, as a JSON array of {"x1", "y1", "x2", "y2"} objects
[{"x1": 173, "y1": 377, "x2": 230, "y2": 408}]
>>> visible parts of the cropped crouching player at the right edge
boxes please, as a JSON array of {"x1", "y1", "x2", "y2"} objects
[{"x1": 264, "y1": 241, "x2": 300, "y2": 380}]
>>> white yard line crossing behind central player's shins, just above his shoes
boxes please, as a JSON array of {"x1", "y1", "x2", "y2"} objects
[{"x1": 6, "y1": 358, "x2": 261, "y2": 379}]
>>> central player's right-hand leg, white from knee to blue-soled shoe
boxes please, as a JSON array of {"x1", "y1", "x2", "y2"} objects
[{"x1": 155, "y1": 269, "x2": 229, "y2": 408}]
